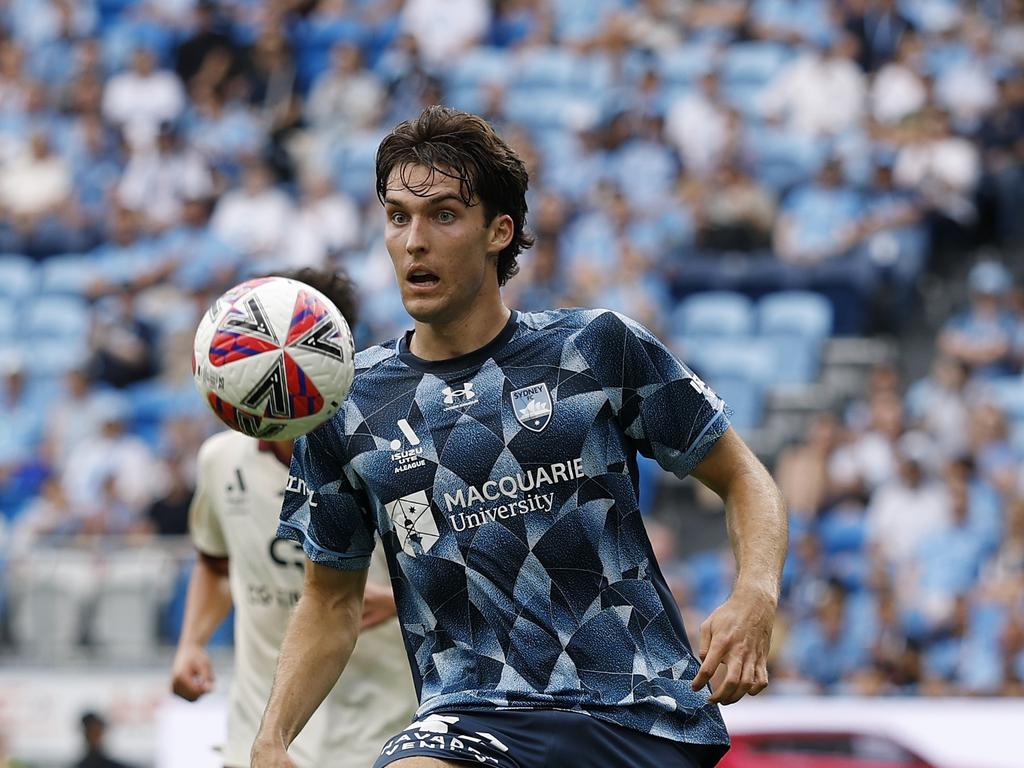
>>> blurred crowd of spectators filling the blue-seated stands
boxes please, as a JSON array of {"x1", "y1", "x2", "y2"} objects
[{"x1": 0, "y1": 0, "x2": 1024, "y2": 693}]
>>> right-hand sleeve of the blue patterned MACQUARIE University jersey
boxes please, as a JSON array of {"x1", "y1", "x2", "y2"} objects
[{"x1": 577, "y1": 311, "x2": 729, "y2": 477}]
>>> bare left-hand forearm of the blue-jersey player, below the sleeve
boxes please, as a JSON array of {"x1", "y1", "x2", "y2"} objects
[{"x1": 251, "y1": 560, "x2": 367, "y2": 768}]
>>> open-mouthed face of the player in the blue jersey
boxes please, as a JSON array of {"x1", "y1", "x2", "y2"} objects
[{"x1": 384, "y1": 165, "x2": 512, "y2": 323}]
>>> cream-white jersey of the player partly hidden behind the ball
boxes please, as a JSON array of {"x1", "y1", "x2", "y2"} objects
[{"x1": 189, "y1": 432, "x2": 416, "y2": 768}]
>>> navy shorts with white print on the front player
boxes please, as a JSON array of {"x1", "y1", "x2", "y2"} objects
[{"x1": 374, "y1": 710, "x2": 726, "y2": 768}]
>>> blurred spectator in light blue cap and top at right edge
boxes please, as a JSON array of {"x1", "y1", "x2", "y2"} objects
[{"x1": 939, "y1": 261, "x2": 1020, "y2": 378}]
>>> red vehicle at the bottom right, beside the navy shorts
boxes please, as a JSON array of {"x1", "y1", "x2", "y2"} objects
[{"x1": 719, "y1": 731, "x2": 938, "y2": 768}]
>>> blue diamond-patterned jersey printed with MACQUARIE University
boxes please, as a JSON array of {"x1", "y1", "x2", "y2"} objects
[{"x1": 279, "y1": 309, "x2": 728, "y2": 744}]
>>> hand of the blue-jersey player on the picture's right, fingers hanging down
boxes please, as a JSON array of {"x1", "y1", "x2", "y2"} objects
[{"x1": 692, "y1": 587, "x2": 777, "y2": 705}]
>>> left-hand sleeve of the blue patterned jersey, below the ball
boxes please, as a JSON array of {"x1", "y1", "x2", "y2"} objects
[{"x1": 278, "y1": 422, "x2": 374, "y2": 570}]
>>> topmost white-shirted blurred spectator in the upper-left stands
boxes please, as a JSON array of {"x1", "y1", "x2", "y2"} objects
[{"x1": 103, "y1": 45, "x2": 185, "y2": 148}]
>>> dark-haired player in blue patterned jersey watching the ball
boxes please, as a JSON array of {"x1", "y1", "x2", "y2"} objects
[{"x1": 253, "y1": 106, "x2": 786, "y2": 768}]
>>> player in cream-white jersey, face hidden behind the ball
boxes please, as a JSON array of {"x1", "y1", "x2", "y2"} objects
[{"x1": 172, "y1": 269, "x2": 416, "y2": 768}]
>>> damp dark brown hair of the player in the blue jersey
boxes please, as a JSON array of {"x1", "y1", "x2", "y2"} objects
[{"x1": 377, "y1": 105, "x2": 534, "y2": 286}]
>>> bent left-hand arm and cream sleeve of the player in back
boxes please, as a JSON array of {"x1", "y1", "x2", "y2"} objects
[{"x1": 171, "y1": 436, "x2": 231, "y2": 701}]
